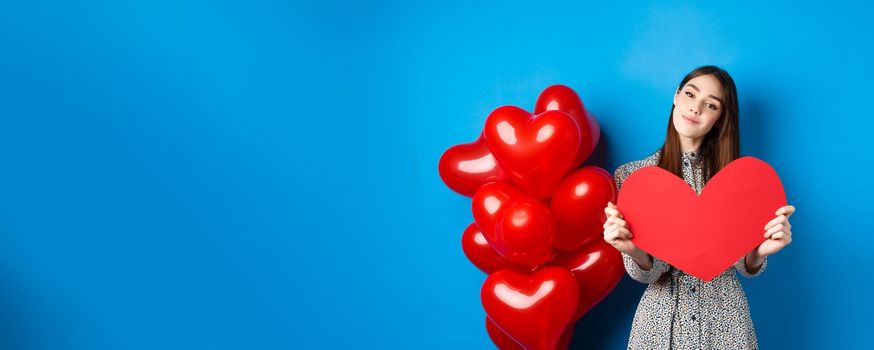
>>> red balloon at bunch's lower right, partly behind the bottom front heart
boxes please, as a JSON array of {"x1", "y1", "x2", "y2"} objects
[{"x1": 549, "y1": 239, "x2": 625, "y2": 321}]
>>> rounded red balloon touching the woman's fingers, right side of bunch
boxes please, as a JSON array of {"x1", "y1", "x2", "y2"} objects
[{"x1": 549, "y1": 165, "x2": 617, "y2": 251}]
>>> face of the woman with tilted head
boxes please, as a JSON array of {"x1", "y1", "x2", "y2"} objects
[{"x1": 673, "y1": 74, "x2": 723, "y2": 139}]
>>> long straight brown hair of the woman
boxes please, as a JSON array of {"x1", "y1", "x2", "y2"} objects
[{"x1": 658, "y1": 66, "x2": 740, "y2": 181}]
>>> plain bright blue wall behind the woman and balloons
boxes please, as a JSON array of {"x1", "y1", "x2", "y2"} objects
[{"x1": 0, "y1": 0, "x2": 874, "y2": 349}]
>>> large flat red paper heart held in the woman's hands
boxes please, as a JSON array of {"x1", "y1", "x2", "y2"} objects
[{"x1": 617, "y1": 157, "x2": 786, "y2": 281}]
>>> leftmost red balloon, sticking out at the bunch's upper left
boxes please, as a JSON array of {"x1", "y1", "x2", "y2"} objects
[{"x1": 438, "y1": 133, "x2": 508, "y2": 197}]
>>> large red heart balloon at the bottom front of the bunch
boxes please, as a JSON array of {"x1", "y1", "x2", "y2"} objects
[{"x1": 480, "y1": 266, "x2": 580, "y2": 350}]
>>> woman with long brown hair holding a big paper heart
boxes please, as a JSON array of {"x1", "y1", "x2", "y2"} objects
[{"x1": 604, "y1": 66, "x2": 795, "y2": 349}]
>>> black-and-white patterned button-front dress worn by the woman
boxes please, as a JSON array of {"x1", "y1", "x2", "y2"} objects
[{"x1": 614, "y1": 150, "x2": 768, "y2": 349}]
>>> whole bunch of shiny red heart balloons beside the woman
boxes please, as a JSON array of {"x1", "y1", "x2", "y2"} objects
[{"x1": 439, "y1": 85, "x2": 624, "y2": 350}]
